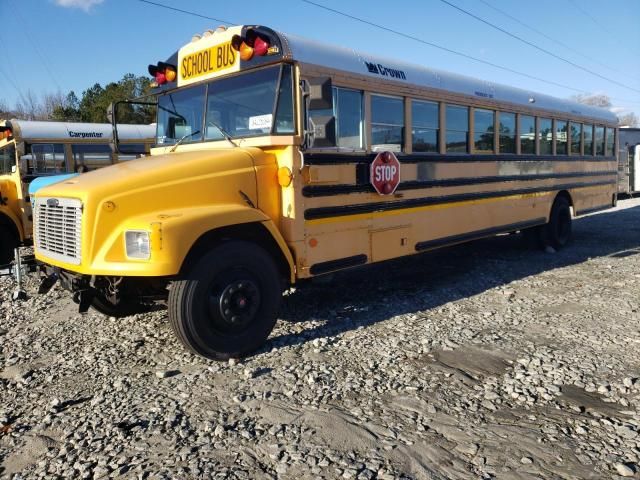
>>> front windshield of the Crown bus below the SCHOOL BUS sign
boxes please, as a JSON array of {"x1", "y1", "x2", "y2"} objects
[{"x1": 157, "y1": 65, "x2": 295, "y2": 145}]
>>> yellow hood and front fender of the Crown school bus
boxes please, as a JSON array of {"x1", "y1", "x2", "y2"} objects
[{"x1": 36, "y1": 148, "x2": 293, "y2": 277}]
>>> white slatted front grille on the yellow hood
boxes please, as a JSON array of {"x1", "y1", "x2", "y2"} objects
[{"x1": 33, "y1": 197, "x2": 82, "y2": 265}]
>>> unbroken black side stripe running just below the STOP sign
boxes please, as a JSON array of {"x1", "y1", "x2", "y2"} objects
[{"x1": 304, "y1": 182, "x2": 612, "y2": 220}]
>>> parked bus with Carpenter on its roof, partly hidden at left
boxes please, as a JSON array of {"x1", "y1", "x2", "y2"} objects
[{"x1": 0, "y1": 119, "x2": 155, "y2": 272}]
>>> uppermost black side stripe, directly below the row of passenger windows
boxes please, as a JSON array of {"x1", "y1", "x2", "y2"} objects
[{"x1": 304, "y1": 152, "x2": 616, "y2": 165}]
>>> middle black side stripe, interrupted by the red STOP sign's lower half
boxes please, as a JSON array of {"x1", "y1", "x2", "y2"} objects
[{"x1": 302, "y1": 170, "x2": 618, "y2": 197}]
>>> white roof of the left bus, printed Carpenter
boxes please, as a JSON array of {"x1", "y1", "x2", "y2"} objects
[{"x1": 0, "y1": 119, "x2": 156, "y2": 141}]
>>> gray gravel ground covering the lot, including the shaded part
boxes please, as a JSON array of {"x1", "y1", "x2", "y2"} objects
[{"x1": 0, "y1": 199, "x2": 640, "y2": 479}]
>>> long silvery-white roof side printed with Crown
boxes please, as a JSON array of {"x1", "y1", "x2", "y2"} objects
[{"x1": 278, "y1": 33, "x2": 618, "y2": 124}]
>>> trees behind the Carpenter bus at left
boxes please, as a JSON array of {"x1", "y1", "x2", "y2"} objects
[{"x1": 0, "y1": 73, "x2": 155, "y2": 124}]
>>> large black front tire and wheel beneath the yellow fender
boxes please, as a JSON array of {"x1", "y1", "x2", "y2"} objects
[{"x1": 169, "y1": 241, "x2": 282, "y2": 360}]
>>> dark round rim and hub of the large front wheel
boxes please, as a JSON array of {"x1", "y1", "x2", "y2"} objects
[{"x1": 208, "y1": 272, "x2": 261, "y2": 335}]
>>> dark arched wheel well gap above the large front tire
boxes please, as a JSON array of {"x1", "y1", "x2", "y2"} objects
[{"x1": 180, "y1": 222, "x2": 291, "y2": 284}]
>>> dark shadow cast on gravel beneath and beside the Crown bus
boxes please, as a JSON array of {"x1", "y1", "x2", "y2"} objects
[{"x1": 270, "y1": 206, "x2": 640, "y2": 351}]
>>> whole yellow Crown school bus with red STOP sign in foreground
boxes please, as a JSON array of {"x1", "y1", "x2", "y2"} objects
[{"x1": 34, "y1": 25, "x2": 617, "y2": 359}]
